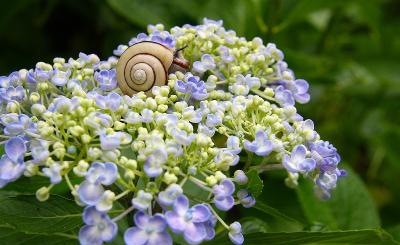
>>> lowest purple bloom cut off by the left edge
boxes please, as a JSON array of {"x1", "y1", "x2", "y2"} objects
[{"x1": 0, "y1": 154, "x2": 25, "y2": 188}]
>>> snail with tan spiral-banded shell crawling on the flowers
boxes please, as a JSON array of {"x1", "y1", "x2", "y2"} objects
[{"x1": 116, "y1": 41, "x2": 189, "y2": 96}]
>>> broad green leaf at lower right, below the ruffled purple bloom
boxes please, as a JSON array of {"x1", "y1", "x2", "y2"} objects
[{"x1": 297, "y1": 165, "x2": 380, "y2": 230}]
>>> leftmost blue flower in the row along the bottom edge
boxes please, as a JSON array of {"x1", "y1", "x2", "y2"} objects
[{"x1": 79, "y1": 207, "x2": 118, "y2": 245}]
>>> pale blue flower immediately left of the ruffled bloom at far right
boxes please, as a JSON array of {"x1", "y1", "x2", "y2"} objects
[{"x1": 282, "y1": 145, "x2": 316, "y2": 173}]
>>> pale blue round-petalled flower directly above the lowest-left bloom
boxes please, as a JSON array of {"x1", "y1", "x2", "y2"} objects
[{"x1": 78, "y1": 162, "x2": 118, "y2": 206}]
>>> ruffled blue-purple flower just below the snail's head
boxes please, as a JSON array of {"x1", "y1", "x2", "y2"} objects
[{"x1": 175, "y1": 73, "x2": 208, "y2": 100}]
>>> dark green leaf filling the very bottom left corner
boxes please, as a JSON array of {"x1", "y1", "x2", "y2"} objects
[{"x1": 0, "y1": 226, "x2": 78, "y2": 245}]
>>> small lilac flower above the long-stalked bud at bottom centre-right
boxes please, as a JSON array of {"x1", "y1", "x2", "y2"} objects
[{"x1": 213, "y1": 179, "x2": 235, "y2": 211}]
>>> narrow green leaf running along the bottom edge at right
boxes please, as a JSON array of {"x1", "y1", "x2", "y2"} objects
[{"x1": 211, "y1": 229, "x2": 396, "y2": 245}]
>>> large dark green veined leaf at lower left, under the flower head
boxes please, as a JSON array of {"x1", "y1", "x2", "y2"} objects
[{"x1": 0, "y1": 195, "x2": 82, "y2": 235}]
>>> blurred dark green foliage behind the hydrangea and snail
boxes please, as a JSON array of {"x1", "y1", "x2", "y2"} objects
[{"x1": 0, "y1": 0, "x2": 400, "y2": 241}]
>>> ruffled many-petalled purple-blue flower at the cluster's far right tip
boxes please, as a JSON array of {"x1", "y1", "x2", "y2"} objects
[{"x1": 310, "y1": 140, "x2": 340, "y2": 171}]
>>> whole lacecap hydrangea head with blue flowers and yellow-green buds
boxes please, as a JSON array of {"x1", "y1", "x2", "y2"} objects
[{"x1": 0, "y1": 19, "x2": 346, "y2": 245}]
